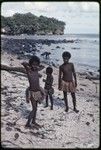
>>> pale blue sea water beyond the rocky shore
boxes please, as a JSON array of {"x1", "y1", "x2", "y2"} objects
[{"x1": 1, "y1": 34, "x2": 100, "y2": 71}]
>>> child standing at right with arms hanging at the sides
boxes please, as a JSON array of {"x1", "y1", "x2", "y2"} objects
[{"x1": 58, "y1": 51, "x2": 79, "y2": 113}]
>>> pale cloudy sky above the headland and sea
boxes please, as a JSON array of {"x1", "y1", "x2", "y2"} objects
[{"x1": 1, "y1": 1, "x2": 100, "y2": 34}]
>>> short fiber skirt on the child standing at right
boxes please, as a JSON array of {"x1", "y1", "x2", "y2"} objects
[{"x1": 60, "y1": 80, "x2": 76, "y2": 92}]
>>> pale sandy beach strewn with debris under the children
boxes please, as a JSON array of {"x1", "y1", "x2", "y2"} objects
[{"x1": 1, "y1": 52, "x2": 100, "y2": 148}]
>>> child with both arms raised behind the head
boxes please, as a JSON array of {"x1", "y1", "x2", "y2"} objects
[{"x1": 22, "y1": 56, "x2": 44, "y2": 127}]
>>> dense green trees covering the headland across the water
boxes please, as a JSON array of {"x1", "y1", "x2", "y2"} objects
[{"x1": 1, "y1": 13, "x2": 65, "y2": 35}]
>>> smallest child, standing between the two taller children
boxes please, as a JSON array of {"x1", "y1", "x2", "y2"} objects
[{"x1": 43, "y1": 67, "x2": 54, "y2": 110}]
